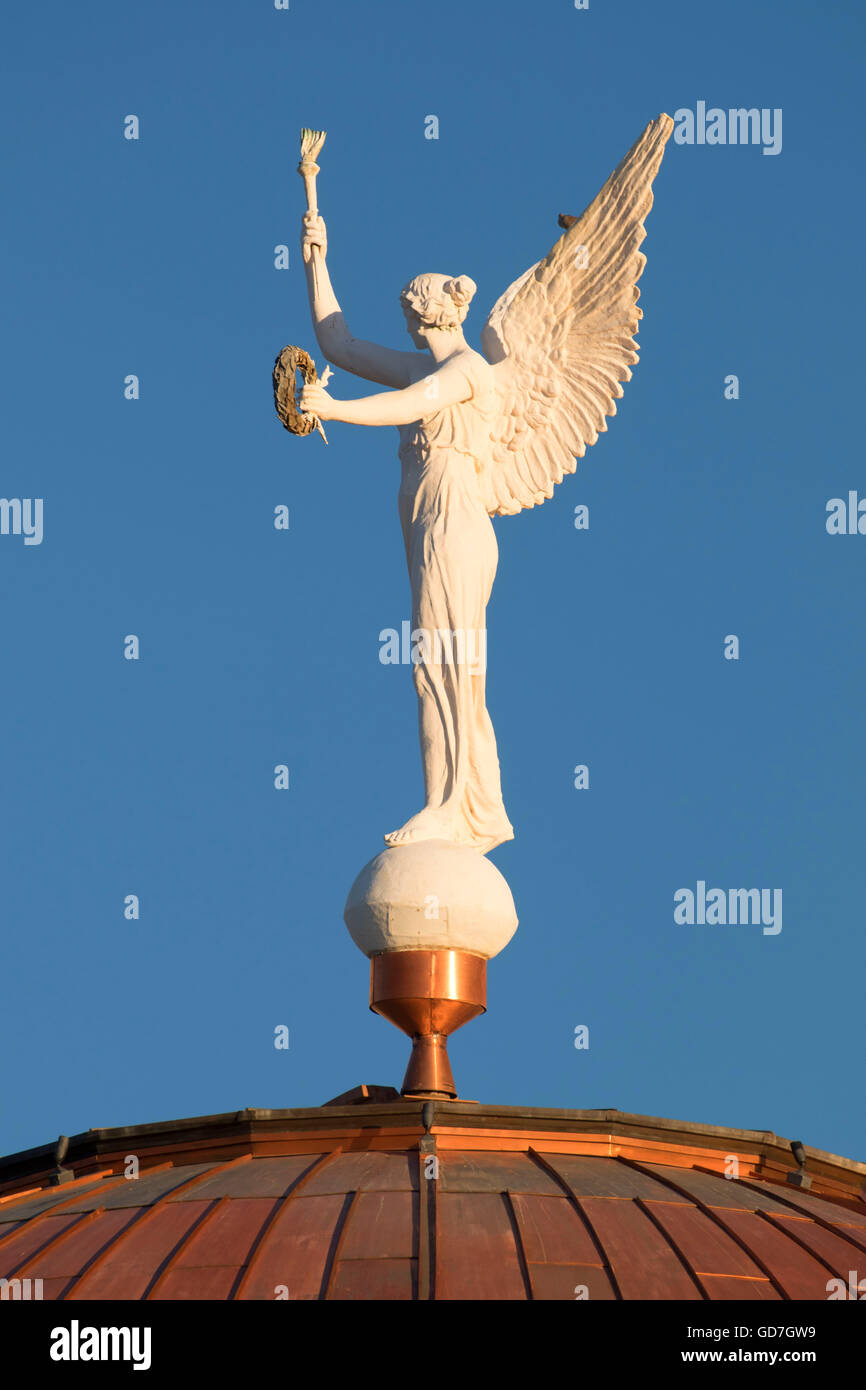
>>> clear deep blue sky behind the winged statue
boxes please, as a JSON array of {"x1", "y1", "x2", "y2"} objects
[{"x1": 0, "y1": 0, "x2": 866, "y2": 1159}]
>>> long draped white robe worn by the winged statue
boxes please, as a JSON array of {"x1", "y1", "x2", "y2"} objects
[{"x1": 399, "y1": 352, "x2": 514, "y2": 853}]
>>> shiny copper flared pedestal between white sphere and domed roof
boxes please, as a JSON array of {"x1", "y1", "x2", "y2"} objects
[{"x1": 370, "y1": 951, "x2": 487, "y2": 1099}]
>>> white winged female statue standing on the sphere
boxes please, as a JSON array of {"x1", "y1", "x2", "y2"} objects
[{"x1": 299, "y1": 114, "x2": 673, "y2": 853}]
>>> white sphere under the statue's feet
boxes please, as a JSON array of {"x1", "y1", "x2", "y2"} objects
[{"x1": 343, "y1": 840, "x2": 517, "y2": 959}]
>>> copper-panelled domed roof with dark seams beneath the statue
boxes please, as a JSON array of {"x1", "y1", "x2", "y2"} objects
[{"x1": 0, "y1": 1087, "x2": 866, "y2": 1301}]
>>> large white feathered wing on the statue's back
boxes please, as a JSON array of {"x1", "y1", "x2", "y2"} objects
[{"x1": 481, "y1": 114, "x2": 674, "y2": 516}]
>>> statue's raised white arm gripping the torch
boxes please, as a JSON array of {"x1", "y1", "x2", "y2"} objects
[{"x1": 300, "y1": 213, "x2": 428, "y2": 388}]
